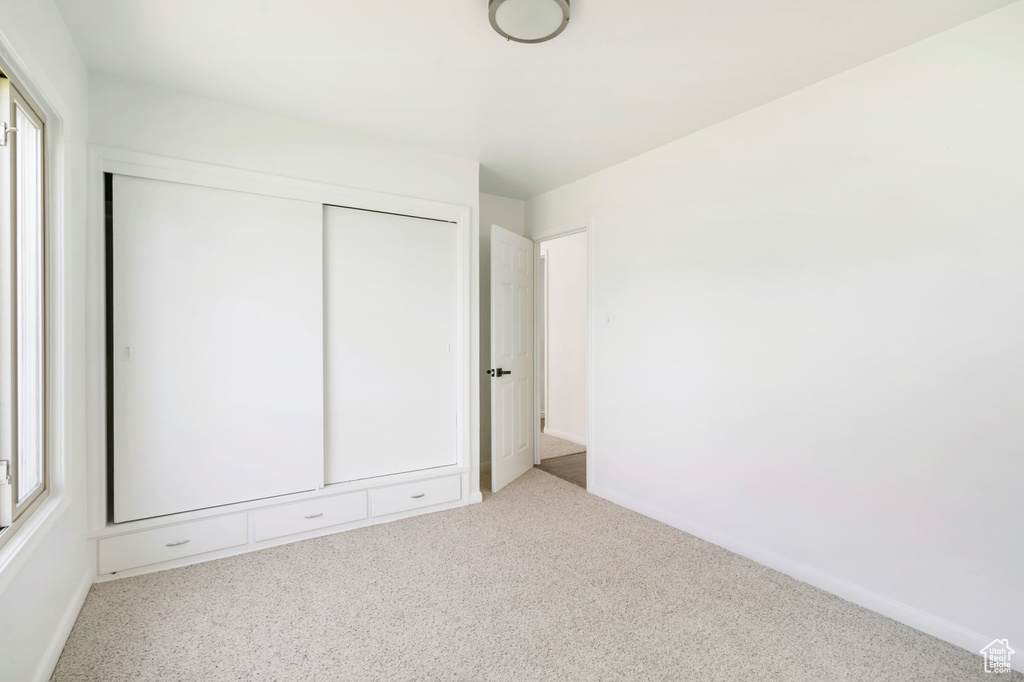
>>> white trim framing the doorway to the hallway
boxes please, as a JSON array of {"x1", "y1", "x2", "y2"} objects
[{"x1": 527, "y1": 218, "x2": 595, "y2": 483}]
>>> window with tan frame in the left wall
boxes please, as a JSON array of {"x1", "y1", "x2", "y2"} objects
[{"x1": 0, "y1": 74, "x2": 48, "y2": 545}]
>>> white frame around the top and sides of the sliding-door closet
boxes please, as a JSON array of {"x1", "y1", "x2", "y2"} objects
[{"x1": 86, "y1": 145, "x2": 480, "y2": 535}]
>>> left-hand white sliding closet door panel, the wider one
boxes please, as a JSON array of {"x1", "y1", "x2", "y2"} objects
[{"x1": 113, "y1": 175, "x2": 324, "y2": 522}]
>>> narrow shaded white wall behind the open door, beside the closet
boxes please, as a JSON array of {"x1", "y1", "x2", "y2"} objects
[{"x1": 480, "y1": 194, "x2": 526, "y2": 471}]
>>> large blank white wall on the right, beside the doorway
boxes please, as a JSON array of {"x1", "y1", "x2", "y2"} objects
[{"x1": 527, "y1": 2, "x2": 1024, "y2": 662}]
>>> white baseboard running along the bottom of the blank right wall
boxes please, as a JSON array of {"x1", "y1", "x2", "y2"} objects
[{"x1": 587, "y1": 483, "x2": 1011, "y2": 672}]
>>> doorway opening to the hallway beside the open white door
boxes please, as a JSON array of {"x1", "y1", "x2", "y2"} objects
[{"x1": 536, "y1": 231, "x2": 589, "y2": 488}]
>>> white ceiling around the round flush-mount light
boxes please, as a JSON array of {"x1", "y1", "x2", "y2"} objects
[{"x1": 56, "y1": 0, "x2": 1010, "y2": 199}]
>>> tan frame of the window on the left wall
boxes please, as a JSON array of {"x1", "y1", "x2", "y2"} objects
[{"x1": 0, "y1": 71, "x2": 52, "y2": 548}]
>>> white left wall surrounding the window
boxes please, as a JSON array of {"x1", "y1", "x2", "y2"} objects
[{"x1": 0, "y1": 0, "x2": 92, "y2": 681}]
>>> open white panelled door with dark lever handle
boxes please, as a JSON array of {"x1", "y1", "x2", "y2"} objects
[{"x1": 487, "y1": 225, "x2": 536, "y2": 493}]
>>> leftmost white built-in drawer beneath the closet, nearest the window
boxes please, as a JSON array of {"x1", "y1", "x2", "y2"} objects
[{"x1": 99, "y1": 514, "x2": 249, "y2": 573}]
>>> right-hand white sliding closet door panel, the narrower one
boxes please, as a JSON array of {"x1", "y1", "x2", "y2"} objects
[{"x1": 324, "y1": 207, "x2": 458, "y2": 483}]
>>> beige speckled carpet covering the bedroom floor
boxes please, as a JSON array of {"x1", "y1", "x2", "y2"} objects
[{"x1": 53, "y1": 469, "x2": 1007, "y2": 682}]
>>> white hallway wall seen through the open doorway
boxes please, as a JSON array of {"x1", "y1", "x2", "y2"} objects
[{"x1": 541, "y1": 232, "x2": 587, "y2": 445}]
